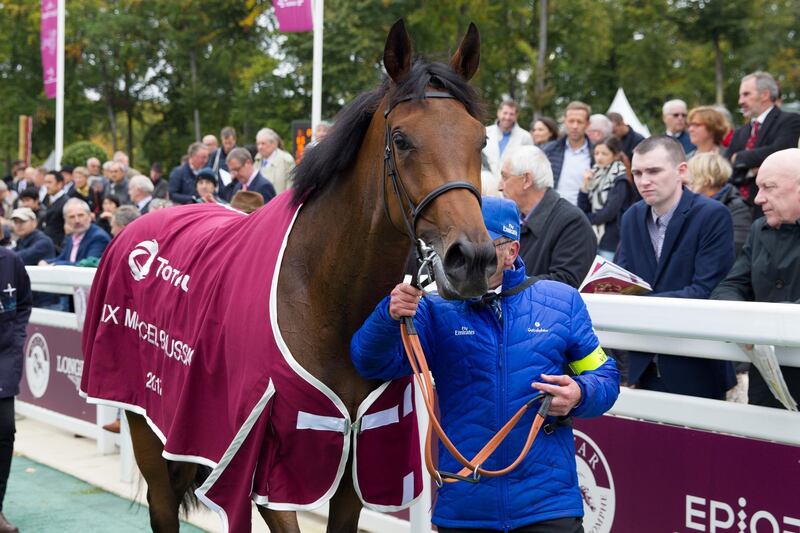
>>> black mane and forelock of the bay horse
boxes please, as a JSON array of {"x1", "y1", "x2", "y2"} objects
[{"x1": 292, "y1": 58, "x2": 485, "y2": 203}]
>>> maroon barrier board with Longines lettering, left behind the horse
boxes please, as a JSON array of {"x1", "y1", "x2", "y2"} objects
[{"x1": 17, "y1": 324, "x2": 97, "y2": 423}]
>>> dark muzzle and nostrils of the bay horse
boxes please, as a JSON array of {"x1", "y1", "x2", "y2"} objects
[{"x1": 435, "y1": 237, "x2": 497, "y2": 300}]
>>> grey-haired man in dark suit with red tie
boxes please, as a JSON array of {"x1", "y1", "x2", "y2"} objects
[{"x1": 726, "y1": 72, "x2": 800, "y2": 210}]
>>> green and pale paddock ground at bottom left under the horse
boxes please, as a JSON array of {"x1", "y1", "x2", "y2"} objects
[{"x1": 10, "y1": 417, "x2": 325, "y2": 533}]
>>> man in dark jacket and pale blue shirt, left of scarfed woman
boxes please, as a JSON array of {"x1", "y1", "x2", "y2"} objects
[{"x1": 544, "y1": 101, "x2": 594, "y2": 205}]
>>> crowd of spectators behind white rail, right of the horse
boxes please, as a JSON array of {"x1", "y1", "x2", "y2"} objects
[{"x1": 482, "y1": 68, "x2": 800, "y2": 407}]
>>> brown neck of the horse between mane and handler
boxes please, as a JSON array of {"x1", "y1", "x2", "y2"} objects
[{"x1": 282, "y1": 127, "x2": 410, "y2": 329}]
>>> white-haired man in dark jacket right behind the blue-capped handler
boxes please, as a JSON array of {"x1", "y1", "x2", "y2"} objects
[{"x1": 498, "y1": 146, "x2": 597, "y2": 288}]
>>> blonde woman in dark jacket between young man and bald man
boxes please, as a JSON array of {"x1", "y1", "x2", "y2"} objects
[{"x1": 688, "y1": 153, "x2": 753, "y2": 256}]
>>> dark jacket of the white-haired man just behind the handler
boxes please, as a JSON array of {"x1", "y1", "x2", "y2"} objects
[{"x1": 519, "y1": 189, "x2": 597, "y2": 288}]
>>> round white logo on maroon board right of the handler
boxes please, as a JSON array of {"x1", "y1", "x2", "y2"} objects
[{"x1": 573, "y1": 430, "x2": 615, "y2": 533}]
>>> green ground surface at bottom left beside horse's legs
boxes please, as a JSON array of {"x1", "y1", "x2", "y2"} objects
[{"x1": 3, "y1": 452, "x2": 203, "y2": 533}]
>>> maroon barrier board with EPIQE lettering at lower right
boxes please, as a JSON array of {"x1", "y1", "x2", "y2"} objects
[{"x1": 575, "y1": 416, "x2": 800, "y2": 533}]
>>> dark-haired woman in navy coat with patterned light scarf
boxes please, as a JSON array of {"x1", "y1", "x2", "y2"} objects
[{"x1": 578, "y1": 133, "x2": 635, "y2": 260}]
